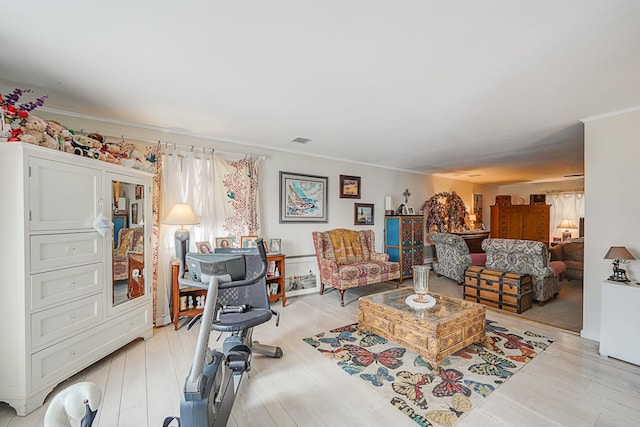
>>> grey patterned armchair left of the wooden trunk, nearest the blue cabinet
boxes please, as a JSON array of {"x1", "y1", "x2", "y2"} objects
[{"x1": 431, "y1": 233, "x2": 472, "y2": 284}]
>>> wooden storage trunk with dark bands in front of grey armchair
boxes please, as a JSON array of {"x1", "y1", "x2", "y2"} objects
[{"x1": 464, "y1": 265, "x2": 533, "y2": 313}]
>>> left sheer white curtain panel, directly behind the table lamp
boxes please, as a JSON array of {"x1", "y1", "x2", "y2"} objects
[{"x1": 155, "y1": 147, "x2": 217, "y2": 326}]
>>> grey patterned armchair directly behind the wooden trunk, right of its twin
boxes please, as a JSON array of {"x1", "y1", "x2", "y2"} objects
[{"x1": 482, "y1": 239, "x2": 560, "y2": 304}]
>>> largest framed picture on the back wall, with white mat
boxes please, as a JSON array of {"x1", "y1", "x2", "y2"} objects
[{"x1": 280, "y1": 171, "x2": 328, "y2": 223}]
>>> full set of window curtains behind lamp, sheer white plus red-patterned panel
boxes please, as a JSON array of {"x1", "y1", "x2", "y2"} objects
[{"x1": 155, "y1": 147, "x2": 260, "y2": 326}]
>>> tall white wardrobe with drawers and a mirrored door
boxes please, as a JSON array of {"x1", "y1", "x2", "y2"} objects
[{"x1": 0, "y1": 143, "x2": 153, "y2": 415}]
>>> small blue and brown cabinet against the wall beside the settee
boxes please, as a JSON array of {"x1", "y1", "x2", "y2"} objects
[{"x1": 384, "y1": 215, "x2": 424, "y2": 279}]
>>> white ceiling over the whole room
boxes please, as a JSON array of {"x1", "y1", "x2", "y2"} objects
[{"x1": 0, "y1": 0, "x2": 640, "y2": 184}]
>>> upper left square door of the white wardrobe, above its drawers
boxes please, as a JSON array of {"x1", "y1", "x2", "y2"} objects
[{"x1": 29, "y1": 157, "x2": 101, "y2": 231}]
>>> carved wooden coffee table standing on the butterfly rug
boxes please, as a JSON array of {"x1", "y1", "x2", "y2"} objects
[{"x1": 358, "y1": 288, "x2": 485, "y2": 368}]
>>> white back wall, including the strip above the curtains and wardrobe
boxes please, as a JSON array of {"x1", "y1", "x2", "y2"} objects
[{"x1": 38, "y1": 109, "x2": 494, "y2": 256}]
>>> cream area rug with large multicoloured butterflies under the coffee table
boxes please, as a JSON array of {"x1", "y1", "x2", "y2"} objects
[{"x1": 304, "y1": 320, "x2": 553, "y2": 427}]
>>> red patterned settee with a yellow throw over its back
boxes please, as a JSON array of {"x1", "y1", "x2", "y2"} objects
[{"x1": 313, "y1": 228, "x2": 400, "y2": 306}]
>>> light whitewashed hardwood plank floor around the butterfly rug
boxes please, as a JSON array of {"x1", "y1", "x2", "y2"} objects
[{"x1": 0, "y1": 284, "x2": 640, "y2": 427}]
